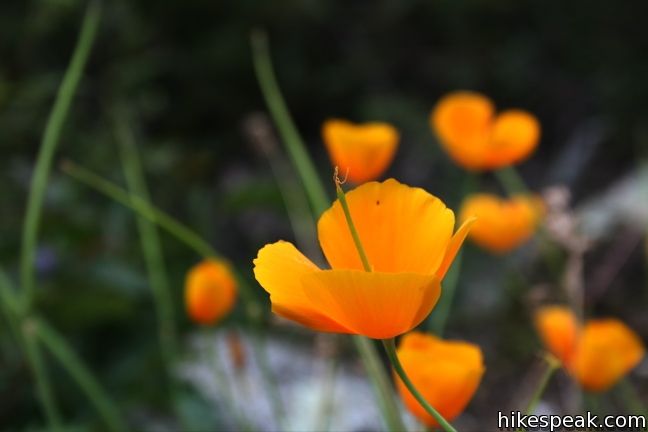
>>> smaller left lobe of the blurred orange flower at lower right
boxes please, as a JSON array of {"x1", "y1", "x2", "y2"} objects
[{"x1": 535, "y1": 306, "x2": 580, "y2": 364}]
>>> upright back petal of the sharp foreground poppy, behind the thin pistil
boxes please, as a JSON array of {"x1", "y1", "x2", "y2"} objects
[{"x1": 317, "y1": 179, "x2": 454, "y2": 274}]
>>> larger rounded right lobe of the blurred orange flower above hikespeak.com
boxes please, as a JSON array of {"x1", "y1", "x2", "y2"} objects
[{"x1": 570, "y1": 319, "x2": 645, "y2": 392}]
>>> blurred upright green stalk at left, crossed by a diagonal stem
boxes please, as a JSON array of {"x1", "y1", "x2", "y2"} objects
[{"x1": 115, "y1": 112, "x2": 177, "y2": 379}]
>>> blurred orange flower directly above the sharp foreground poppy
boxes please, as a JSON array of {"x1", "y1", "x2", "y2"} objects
[{"x1": 322, "y1": 120, "x2": 399, "y2": 184}]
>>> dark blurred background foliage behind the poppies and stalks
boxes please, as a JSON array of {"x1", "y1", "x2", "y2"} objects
[{"x1": 0, "y1": 0, "x2": 648, "y2": 430}]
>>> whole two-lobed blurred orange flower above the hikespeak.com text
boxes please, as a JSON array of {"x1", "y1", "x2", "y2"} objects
[{"x1": 536, "y1": 306, "x2": 645, "y2": 392}]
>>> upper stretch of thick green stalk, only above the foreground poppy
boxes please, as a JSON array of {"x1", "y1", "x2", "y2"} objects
[{"x1": 251, "y1": 31, "x2": 327, "y2": 215}]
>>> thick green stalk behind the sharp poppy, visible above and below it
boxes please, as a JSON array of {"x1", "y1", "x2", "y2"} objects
[{"x1": 252, "y1": 31, "x2": 405, "y2": 430}]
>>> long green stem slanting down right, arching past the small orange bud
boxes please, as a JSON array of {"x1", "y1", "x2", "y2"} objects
[{"x1": 62, "y1": 161, "x2": 282, "y2": 422}]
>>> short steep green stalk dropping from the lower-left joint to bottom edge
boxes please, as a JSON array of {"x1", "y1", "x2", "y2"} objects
[{"x1": 23, "y1": 321, "x2": 62, "y2": 432}]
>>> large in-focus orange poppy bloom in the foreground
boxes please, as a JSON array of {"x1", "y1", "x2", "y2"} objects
[{"x1": 254, "y1": 179, "x2": 472, "y2": 339}]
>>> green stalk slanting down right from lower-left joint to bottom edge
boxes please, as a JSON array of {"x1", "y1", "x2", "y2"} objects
[{"x1": 32, "y1": 319, "x2": 126, "y2": 431}]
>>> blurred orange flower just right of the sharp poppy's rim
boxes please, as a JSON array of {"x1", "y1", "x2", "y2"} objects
[{"x1": 459, "y1": 194, "x2": 544, "y2": 253}]
